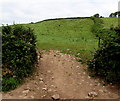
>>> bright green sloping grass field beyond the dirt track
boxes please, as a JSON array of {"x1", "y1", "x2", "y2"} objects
[{"x1": 25, "y1": 18, "x2": 118, "y2": 62}]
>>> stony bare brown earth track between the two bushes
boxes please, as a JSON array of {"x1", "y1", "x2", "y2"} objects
[{"x1": 2, "y1": 50, "x2": 119, "y2": 99}]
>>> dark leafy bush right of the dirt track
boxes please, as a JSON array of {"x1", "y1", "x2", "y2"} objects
[{"x1": 88, "y1": 27, "x2": 120, "y2": 83}]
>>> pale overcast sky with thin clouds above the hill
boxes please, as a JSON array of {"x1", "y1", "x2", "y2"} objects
[{"x1": 0, "y1": 0, "x2": 119, "y2": 24}]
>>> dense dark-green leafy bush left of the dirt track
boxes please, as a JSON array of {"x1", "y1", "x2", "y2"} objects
[{"x1": 2, "y1": 25, "x2": 37, "y2": 91}]
